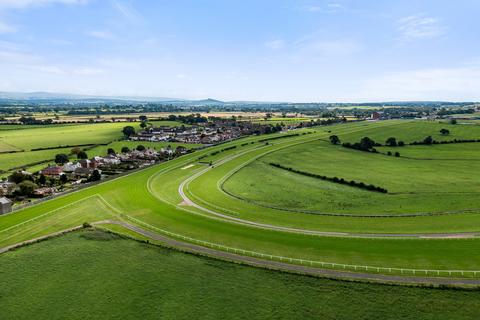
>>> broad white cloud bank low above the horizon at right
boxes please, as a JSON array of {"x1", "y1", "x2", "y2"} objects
[{"x1": 360, "y1": 65, "x2": 480, "y2": 101}]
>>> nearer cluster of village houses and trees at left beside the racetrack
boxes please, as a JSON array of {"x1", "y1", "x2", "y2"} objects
[{"x1": 0, "y1": 145, "x2": 191, "y2": 214}]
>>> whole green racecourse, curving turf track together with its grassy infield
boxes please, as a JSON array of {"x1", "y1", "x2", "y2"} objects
[{"x1": 0, "y1": 121, "x2": 480, "y2": 283}]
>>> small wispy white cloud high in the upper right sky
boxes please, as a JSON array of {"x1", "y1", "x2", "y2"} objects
[{"x1": 397, "y1": 14, "x2": 446, "y2": 40}]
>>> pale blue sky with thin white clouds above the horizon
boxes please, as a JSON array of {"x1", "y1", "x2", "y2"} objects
[{"x1": 0, "y1": 0, "x2": 480, "y2": 102}]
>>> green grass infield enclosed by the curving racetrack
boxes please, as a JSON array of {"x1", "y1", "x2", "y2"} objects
[{"x1": 224, "y1": 122, "x2": 480, "y2": 215}]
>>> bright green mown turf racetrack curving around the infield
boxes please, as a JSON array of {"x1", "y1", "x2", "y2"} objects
[{"x1": 0, "y1": 121, "x2": 480, "y2": 276}]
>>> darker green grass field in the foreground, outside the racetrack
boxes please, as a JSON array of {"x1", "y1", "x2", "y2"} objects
[{"x1": 0, "y1": 231, "x2": 480, "y2": 320}]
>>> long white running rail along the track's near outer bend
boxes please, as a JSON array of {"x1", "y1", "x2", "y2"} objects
[{"x1": 124, "y1": 215, "x2": 480, "y2": 277}]
